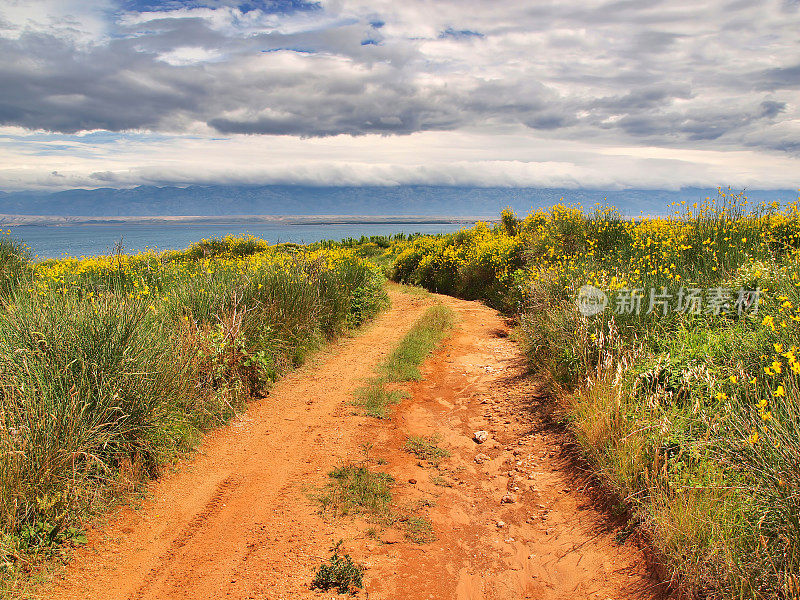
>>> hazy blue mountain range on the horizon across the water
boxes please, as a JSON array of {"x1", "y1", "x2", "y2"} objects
[{"x1": 0, "y1": 185, "x2": 797, "y2": 217}]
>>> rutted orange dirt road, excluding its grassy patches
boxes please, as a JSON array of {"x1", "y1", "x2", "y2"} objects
[{"x1": 43, "y1": 287, "x2": 655, "y2": 600}]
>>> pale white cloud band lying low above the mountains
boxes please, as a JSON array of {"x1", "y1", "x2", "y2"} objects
[{"x1": 0, "y1": 130, "x2": 800, "y2": 189}]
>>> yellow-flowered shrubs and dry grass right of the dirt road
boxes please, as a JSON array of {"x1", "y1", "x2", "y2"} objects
[{"x1": 386, "y1": 190, "x2": 800, "y2": 599}]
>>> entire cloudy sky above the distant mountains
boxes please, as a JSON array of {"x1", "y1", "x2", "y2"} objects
[{"x1": 0, "y1": 0, "x2": 800, "y2": 191}]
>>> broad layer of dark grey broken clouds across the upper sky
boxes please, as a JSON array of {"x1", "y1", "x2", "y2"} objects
[{"x1": 0, "y1": 0, "x2": 800, "y2": 151}]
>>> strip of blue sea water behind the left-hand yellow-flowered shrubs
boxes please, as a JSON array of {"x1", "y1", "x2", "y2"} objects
[{"x1": 10, "y1": 222, "x2": 464, "y2": 258}]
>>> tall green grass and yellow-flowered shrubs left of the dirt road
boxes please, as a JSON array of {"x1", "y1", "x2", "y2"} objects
[{"x1": 0, "y1": 236, "x2": 388, "y2": 590}]
